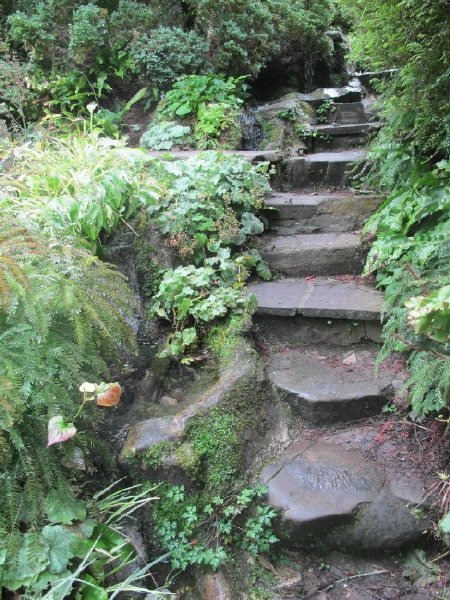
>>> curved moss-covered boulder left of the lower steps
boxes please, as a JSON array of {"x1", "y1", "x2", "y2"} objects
[{"x1": 120, "y1": 317, "x2": 286, "y2": 493}]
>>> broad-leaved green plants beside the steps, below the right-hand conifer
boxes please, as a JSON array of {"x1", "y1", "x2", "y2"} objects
[{"x1": 366, "y1": 161, "x2": 450, "y2": 418}]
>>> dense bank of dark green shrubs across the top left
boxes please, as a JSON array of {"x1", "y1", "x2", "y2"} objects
[{"x1": 0, "y1": 0, "x2": 335, "y2": 131}]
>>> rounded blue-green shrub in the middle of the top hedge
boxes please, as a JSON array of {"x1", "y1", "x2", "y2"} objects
[{"x1": 130, "y1": 27, "x2": 209, "y2": 90}]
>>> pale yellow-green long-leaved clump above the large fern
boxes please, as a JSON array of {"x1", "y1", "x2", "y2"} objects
[{"x1": 0, "y1": 132, "x2": 158, "y2": 250}]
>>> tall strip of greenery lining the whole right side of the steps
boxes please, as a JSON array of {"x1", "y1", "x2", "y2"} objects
[{"x1": 340, "y1": 0, "x2": 450, "y2": 418}]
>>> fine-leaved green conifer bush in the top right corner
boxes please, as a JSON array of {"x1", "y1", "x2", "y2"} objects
[{"x1": 339, "y1": 0, "x2": 450, "y2": 157}]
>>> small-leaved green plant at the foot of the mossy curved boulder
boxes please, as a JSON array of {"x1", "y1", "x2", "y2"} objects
[{"x1": 153, "y1": 486, "x2": 278, "y2": 570}]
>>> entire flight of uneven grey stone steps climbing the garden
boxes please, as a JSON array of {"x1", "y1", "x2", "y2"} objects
[{"x1": 248, "y1": 90, "x2": 425, "y2": 550}]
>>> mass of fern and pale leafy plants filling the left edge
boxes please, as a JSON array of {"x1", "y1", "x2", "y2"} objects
[{"x1": 0, "y1": 134, "x2": 167, "y2": 598}]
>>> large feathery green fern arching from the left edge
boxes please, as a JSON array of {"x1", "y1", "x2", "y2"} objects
[{"x1": 0, "y1": 218, "x2": 135, "y2": 556}]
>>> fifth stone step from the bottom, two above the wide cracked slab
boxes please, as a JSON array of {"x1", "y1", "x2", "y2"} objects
[{"x1": 266, "y1": 190, "x2": 383, "y2": 235}]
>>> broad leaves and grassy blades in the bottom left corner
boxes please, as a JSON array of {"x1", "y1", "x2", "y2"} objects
[{"x1": 0, "y1": 482, "x2": 161, "y2": 600}]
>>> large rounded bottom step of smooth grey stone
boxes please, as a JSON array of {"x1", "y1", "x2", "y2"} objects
[{"x1": 261, "y1": 434, "x2": 426, "y2": 551}]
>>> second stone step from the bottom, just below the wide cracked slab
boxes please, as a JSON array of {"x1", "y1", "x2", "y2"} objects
[{"x1": 267, "y1": 344, "x2": 394, "y2": 425}]
